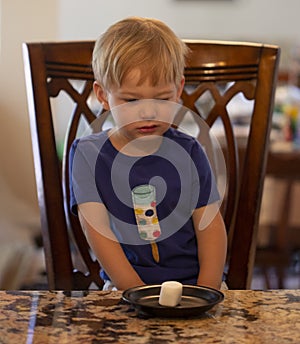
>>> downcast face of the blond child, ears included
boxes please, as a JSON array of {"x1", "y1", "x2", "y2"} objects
[{"x1": 94, "y1": 69, "x2": 184, "y2": 141}]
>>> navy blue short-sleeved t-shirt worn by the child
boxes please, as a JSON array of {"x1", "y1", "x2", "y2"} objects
[{"x1": 70, "y1": 128, "x2": 219, "y2": 284}]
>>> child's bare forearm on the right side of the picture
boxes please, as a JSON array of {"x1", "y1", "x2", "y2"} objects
[{"x1": 193, "y1": 204, "x2": 227, "y2": 289}]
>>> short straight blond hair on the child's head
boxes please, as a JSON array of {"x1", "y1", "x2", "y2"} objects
[{"x1": 92, "y1": 17, "x2": 188, "y2": 89}]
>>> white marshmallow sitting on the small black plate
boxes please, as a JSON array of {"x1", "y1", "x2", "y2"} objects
[{"x1": 158, "y1": 281, "x2": 182, "y2": 307}]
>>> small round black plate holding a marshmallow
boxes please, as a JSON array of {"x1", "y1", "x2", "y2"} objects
[{"x1": 122, "y1": 285, "x2": 224, "y2": 318}]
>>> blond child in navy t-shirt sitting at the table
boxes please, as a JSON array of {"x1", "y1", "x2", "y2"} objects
[{"x1": 70, "y1": 17, "x2": 227, "y2": 290}]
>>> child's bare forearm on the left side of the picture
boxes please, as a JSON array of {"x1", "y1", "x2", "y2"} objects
[{"x1": 78, "y1": 202, "x2": 145, "y2": 290}]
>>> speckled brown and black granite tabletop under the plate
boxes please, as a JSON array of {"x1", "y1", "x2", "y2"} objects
[{"x1": 0, "y1": 290, "x2": 300, "y2": 344}]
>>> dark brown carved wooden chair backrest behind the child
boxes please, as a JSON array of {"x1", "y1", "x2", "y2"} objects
[{"x1": 23, "y1": 41, "x2": 280, "y2": 290}]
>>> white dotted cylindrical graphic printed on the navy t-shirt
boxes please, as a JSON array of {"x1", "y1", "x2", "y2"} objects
[{"x1": 131, "y1": 184, "x2": 161, "y2": 241}]
